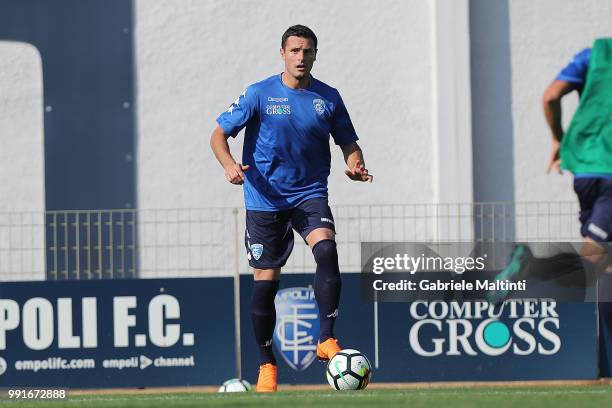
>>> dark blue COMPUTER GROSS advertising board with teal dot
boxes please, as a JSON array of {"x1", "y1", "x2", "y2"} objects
[{"x1": 374, "y1": 299, "x2": 598, "y2": 381}]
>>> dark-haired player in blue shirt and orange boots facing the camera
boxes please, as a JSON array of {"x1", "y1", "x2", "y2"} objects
[{"x1": 210, "y1": 25, "x2": 372, "y2": 392}]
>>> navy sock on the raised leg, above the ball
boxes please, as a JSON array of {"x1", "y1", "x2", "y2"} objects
[{"x1": 312, "y1": 239, "x2": 342, "y2": 342}]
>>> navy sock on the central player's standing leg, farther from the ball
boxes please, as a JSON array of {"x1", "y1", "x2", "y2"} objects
[{"x1": 251, "y1": 280, "x2": 279, "y2": 365}]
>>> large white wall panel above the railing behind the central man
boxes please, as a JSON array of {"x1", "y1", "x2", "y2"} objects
[{"x1": 135, "y1": 0, "x2": 434, "y2": 208}]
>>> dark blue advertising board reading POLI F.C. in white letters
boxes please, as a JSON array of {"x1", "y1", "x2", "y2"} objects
[{"x1": 0, "y1": 278, "x2": 236, "y2": 388}]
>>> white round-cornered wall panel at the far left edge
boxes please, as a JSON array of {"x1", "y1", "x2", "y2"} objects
[{"x1": 0, "y1": 41, "x2": 45, "y2": 281}]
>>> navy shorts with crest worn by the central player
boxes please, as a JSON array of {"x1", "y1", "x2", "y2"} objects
[{"x1": 244, "y1": 198, "x2": 335, "y2": 269}]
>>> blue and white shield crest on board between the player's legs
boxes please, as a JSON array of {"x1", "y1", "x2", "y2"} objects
[{"x1": 273, "y1": 286, "x2": 319, "y2": 371}]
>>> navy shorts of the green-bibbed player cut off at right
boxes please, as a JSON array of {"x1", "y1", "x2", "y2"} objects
[{"x1": 574, "y1": 177, "x2": 612, "y2": 242}]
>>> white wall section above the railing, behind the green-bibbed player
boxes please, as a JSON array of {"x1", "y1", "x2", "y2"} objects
[{"x1": 509, "y1": 0, "x2": 612, "y2": 201}]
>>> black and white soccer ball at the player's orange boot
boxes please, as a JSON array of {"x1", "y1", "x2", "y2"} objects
[{"x1": 326, "y1": 349, "x2": 372, "y2": 390}]
